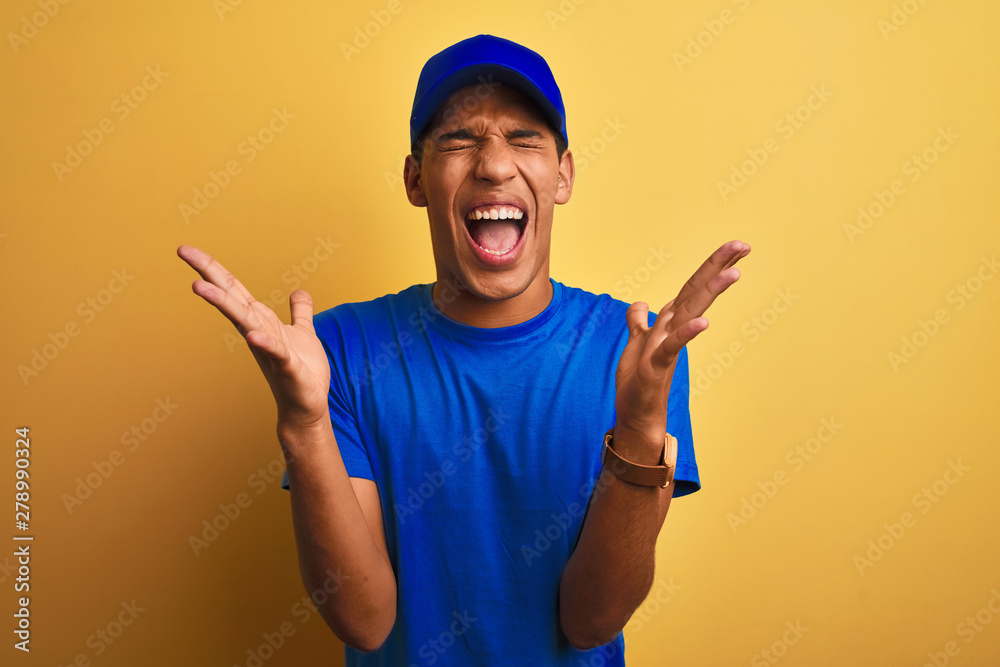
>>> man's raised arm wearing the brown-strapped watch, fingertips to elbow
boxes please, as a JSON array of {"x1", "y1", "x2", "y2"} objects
[{"x1": 559, "y1": 241, "x2": 750, "y2": 649}]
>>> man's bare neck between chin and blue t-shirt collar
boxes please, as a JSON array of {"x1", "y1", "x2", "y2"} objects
[{"x1": 431, "y1": 274, "x2": 552, "y2": 329}]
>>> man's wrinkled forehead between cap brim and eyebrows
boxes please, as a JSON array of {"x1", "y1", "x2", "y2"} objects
[{"x1": 427, "y1": 84, "x2": 548, "y2": 137}]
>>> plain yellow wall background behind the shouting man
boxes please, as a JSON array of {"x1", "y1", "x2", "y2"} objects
[{"x1": 0, "y1": 0, "x2": 1000, "y2": 667}]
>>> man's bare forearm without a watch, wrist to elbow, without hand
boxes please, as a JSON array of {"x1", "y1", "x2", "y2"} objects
[{"x1": 278, "y1": 419, "x2": 396, "y2": 650}]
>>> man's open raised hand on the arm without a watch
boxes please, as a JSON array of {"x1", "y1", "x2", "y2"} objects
[{"x1": 177, "y1": 245, "x2": 330, "y2": 428}]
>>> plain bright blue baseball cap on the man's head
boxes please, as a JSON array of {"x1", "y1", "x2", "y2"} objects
[{"x1": 410, "y1": 35, "x2": 569, "y2": 145}]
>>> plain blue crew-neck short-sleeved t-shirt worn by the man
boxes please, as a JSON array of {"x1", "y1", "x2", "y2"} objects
[{"x1": 282, "y1": 278, "x2": 700, "y2": 667}]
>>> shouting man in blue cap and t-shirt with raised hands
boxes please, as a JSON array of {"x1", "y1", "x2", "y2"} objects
[{"x1": 178, "y1": 35, "x2": 750, "y2": 667}]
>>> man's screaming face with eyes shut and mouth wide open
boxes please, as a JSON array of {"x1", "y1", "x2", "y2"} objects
[{"x1": 404, "y1": 85, "x2": 574, "y2": 301}]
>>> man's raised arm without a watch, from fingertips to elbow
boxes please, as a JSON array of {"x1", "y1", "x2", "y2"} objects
[{"x1": 177, "y1": 246, "x2": 396, "y2": 651}]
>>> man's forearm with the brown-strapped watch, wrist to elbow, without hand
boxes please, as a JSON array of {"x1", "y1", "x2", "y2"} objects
[{"x1": 559, "y1": 427, "x2": 673, "y2": 649}]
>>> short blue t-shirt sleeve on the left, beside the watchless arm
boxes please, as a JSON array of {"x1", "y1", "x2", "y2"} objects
[{"x1": 281, "y1": 311, "x2": 375, "y2": 489}]
